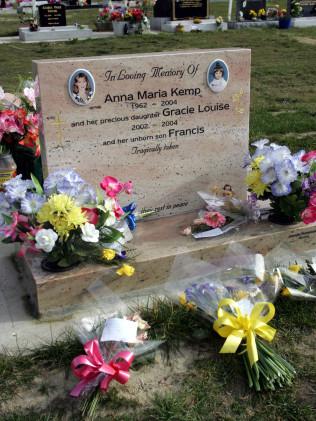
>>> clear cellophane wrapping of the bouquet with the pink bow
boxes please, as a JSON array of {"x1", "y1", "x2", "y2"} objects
[{"x1": 73, "y1": 286, "x2": 162, "y2": 400}]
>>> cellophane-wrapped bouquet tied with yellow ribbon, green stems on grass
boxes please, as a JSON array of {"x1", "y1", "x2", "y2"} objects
[{"x1": 167, "y1": 249, "x2": 295, "y2": 391}]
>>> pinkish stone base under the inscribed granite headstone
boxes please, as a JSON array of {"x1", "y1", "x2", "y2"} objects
[{"x1": 21, "y1": 213, "x2": 316, "y2": 319}]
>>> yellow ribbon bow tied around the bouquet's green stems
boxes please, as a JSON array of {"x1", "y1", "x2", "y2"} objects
[{"x1": 213, "y1": 298, "x2": 276, "y2": 366}]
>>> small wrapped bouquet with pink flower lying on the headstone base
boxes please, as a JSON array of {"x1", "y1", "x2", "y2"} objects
[{"x1": 182, "y1": 184, "x2": 259, "y2": 239}]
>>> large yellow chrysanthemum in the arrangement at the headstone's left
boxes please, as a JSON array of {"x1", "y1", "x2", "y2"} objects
[{"x1": 37, "y1": 194, "x2": 87, "y2": 238}]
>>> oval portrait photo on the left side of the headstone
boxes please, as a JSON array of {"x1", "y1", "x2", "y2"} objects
[{"x1": 68, "y1": 69, "x2": 95, "y2": 105}]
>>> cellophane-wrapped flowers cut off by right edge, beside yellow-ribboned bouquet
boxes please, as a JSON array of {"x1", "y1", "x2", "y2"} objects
[{"x1": 266, "y1": 244, "x2": 316, "y2": 300}]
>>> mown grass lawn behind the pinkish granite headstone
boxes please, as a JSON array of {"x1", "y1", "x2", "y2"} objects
[{"x1": 0, "y1": 28, "x2": 316, "y2": 150}]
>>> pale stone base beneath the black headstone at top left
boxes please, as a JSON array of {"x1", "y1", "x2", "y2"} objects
[{"x1": 19, "y1": 25, "x2": 93, "y2": 41}]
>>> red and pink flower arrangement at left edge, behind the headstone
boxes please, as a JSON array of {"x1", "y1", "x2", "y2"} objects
[{"x1": 0, "y1": 80, "x2": 41, "y2": 187}]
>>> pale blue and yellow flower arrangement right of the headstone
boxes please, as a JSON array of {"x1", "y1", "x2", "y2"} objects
[{"x1": 246, "y1": 139, "x2": 316, "y2": 224}]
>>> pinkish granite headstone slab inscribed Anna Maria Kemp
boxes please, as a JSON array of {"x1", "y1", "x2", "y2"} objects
[{"x1": 34, "y1": 49, "x2": 250, "y2": 216}]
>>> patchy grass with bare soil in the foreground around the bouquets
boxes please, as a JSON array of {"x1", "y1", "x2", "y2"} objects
[{"x1": 0, "y1": 299, "x2": 316, "y2": 421}]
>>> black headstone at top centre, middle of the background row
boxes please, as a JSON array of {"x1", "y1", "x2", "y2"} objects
[{"x1": 154, "y1": 0, "x2": 208, "y2": 20}]
